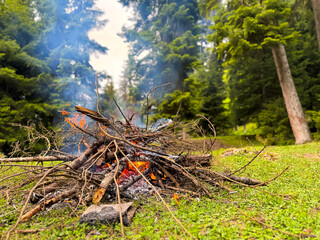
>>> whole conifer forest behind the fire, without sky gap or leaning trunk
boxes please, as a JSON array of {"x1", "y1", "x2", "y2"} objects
[{"x1": 0, "y1": 0, "x2": 320, "y2": 154}]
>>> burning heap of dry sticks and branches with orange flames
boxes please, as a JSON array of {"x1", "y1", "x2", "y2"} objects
[{"x1": 0, "y1": 103, "x2": 284, "y2": 238}]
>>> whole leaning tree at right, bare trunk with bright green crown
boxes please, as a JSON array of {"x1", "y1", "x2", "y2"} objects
[{"x1": 204, "y1": 0, "x2": 311, "y2": 143}]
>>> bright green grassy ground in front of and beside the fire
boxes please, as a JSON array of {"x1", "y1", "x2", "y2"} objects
[{"x1": 0, "y1": 139, "x2": 320, "y2": 239}]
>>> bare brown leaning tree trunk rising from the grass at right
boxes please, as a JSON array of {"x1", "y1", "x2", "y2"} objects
[{"x1": 272, "y1": 44, "x2": 311, "y2": 144}]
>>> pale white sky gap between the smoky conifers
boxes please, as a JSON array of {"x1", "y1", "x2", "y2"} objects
[{"x1": 89, "y1": 0, "x2": 133, "y2": 88}]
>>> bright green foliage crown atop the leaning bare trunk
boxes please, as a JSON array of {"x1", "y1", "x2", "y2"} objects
[{"x1": 209, "y1": 0, "x2": 298, "y2": 63}]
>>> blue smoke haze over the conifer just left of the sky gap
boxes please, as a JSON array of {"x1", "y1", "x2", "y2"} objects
[{"x1": 38, "y1": 0, "x2": 107, "y2": 109}]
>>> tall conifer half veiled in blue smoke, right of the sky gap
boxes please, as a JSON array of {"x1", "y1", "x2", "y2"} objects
[{"x1": 121, "y1": 0, "x2": 201, "y2": 122}]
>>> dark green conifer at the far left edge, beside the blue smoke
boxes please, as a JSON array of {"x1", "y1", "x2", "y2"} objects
[{"x1": 0, "y1": 1, "x2": 58, "y2": 153}]
